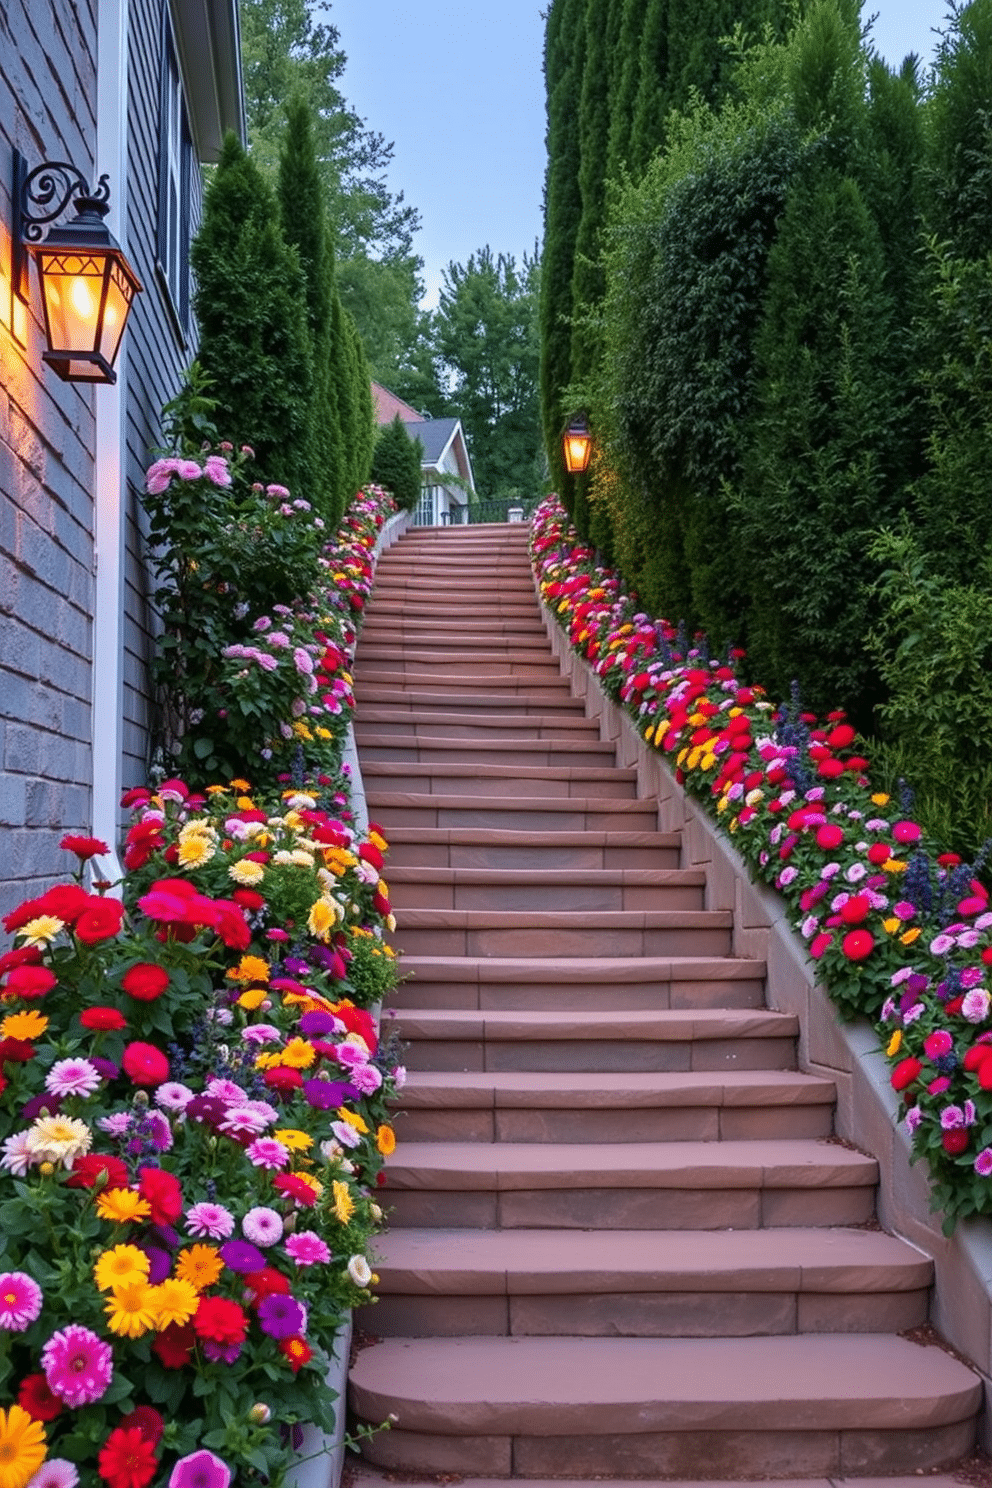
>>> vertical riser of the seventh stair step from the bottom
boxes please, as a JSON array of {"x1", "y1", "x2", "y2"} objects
[{"x1": 393, "y1": 921, "x2": 730, "y2": 957}]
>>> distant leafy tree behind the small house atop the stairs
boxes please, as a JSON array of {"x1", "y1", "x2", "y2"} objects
[{"x1": 434, "y1": 246, "x2": 541, "y2": 498}]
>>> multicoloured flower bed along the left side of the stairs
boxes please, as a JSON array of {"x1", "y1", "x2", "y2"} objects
[{"x1": 0, "y1": 497, "x2": 403, "y2": 1488}]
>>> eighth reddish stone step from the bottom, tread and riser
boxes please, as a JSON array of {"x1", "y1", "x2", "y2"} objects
[{"x1": 387, "y1": 860, "x2": 706, "y2": 912}]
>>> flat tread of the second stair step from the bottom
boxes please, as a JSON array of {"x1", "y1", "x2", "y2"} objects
[{"x1": 376, "y1": 1228, "x2": 933, "y2": 1296}]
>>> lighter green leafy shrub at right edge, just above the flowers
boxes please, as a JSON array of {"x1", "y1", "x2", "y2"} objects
[{"x1": 869, "y1": 521, "x2": 992, "y2": 856}]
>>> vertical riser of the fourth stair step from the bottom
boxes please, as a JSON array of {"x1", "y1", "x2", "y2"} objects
[{"x1": 396, "y1": 1106, "x2": 833, "y2": 1155}]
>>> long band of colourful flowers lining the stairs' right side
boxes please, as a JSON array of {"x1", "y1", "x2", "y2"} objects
[{"x1": 531, "y1": 497, "x2": 992, "y2": 1229}]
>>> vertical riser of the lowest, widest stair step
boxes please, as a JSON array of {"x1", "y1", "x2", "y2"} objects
[{"x1": 356, "y1": 1408, "x2": 976, "y2": 1484}]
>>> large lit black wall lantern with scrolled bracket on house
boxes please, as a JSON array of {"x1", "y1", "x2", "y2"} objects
[{"x1": 10, "y1": 150, "x2": 141, "y2": 382}]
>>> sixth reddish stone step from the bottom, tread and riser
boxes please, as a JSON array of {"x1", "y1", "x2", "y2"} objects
[{"x1": 391, "y1": 949, "x2": 766, "y2": 1011}]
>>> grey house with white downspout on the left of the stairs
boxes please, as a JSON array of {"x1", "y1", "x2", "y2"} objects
[{"x1": 0, "y1": 0, "x2": 244, "y2": 911}]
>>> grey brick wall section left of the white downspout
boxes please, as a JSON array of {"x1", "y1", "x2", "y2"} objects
[{"x1": 0, "y1": 0, "x2": 98, "y2": 912}]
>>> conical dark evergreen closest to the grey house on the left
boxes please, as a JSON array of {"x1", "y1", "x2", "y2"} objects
[{"x1": 190, "y1": 134, "x2": 314, "y2": 491}]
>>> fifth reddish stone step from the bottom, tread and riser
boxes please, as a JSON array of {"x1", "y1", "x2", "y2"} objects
[{"x1": 396, "y1": 1005, "x2": 799, "y2": 1073}]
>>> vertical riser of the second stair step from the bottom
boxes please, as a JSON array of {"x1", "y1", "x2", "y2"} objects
[{"x1": 355, "y1": 1269, "x2": 930, "y2": 1338}]
